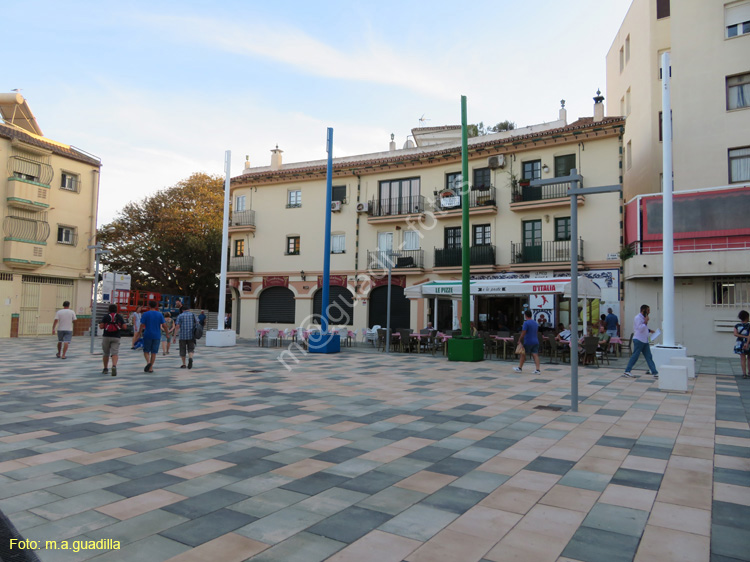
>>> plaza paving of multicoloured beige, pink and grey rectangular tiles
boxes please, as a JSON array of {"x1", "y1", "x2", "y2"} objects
[{"x1": 0, "y1": 338, "x2": 750, "y2": 562}]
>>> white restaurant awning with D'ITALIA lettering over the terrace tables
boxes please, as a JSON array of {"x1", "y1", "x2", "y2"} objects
[{"x1": 404, "y1": 276, "x2": 602, "y2": 299}]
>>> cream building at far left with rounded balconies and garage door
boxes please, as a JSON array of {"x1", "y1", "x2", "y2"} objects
[{"x1": 0, "y1": 94, "x2": 101, "y2": 337}]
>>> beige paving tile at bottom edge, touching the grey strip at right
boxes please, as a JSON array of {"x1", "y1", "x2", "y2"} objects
[{"x1": 635, "y1": 525, "x2": 711, "y2": 562}]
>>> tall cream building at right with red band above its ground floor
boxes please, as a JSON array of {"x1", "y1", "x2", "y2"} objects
[{"x1": 607, "y1": 0, "x2": 750, "y2": 356}]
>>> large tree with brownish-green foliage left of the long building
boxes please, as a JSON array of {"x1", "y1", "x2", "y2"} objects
[{"x1": 98, "y1": 173, "x2": 224, "y2": 306}]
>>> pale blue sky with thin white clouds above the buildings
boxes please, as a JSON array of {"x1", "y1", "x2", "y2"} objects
[{"x1": 0, "y1": 0, "x2": 630, "y2": 226}]
